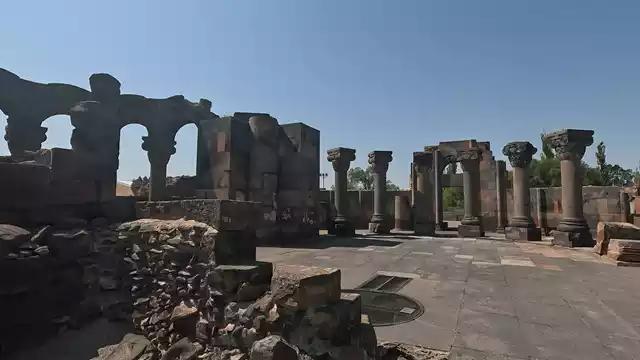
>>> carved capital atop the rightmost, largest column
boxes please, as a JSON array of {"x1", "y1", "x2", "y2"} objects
[{"x1": 543, "y1": 129, "x2": 594, "y2": 161}]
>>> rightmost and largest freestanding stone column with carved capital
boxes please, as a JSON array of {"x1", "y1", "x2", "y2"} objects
[{"x1": 543, "y1": 129, "x2": 594, "y2": 247}]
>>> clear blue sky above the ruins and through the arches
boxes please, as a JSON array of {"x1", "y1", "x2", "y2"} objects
[{"x1": 0, "y1": 0, "x2": 640, "y2": 187}]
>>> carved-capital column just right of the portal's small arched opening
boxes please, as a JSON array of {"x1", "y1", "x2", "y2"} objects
[{"x1": 456, "y1": 147, "x2": 484, "y2": 237}]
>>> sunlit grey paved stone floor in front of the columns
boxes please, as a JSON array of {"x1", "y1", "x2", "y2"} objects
[{"x1": 258, "y1": 234, "x2": 640, "y2": 360}]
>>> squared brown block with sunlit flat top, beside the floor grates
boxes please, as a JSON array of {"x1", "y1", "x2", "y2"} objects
[{"x1": 271, "y1": 264, "x2": 340, "y2": 310}]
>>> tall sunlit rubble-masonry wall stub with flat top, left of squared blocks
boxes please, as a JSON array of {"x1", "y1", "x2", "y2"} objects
[{"x1": 118, "y1": 219, "x2": 222, "y2": 351}]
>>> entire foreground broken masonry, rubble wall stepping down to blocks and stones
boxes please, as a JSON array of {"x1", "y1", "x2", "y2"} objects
[{"x1": 118, "y1": 219, "x2": 377, "y2": 360}]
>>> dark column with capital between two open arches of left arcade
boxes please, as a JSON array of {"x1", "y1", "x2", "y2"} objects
[{"x1": 142, "y1": 136, "x2": 176, "y2": 201}]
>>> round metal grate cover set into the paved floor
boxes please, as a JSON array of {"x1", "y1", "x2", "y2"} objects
[{"x1": 342, "y1": 289, "x2": 424, "y2": 326}]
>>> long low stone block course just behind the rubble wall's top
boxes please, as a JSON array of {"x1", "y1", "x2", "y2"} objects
[{"x1": 136, "y1": 199, "x2": 263, "y2": 231}]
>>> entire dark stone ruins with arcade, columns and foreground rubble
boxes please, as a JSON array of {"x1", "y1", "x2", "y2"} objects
[{"x1": 0, "y1": 69, "x2": 640, "y2": 360}]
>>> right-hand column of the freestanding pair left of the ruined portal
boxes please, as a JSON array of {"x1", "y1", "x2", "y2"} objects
[{"x1": 369, "y1": 151, "x2": 393, "y2": 234}]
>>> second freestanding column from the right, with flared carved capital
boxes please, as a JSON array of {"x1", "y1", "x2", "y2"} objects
[{"x1": 502, "y1": 141, "x2": 542, "y2": 241}]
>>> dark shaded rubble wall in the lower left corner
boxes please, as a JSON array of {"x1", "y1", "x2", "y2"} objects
[{"x1": 0, "y1": 219, "x2": 127, "y2": 355}]
